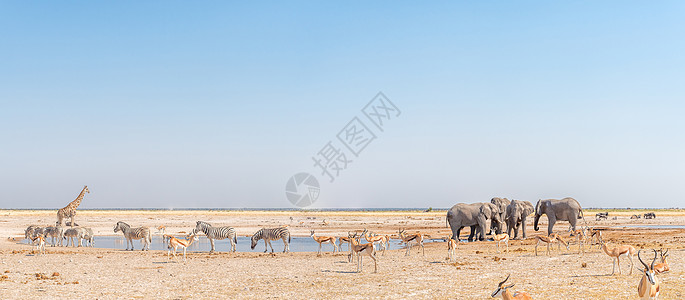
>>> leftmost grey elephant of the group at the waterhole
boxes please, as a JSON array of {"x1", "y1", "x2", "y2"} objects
[{"x1": 445, "y1": 203, "x2": 501, "y2": 241}]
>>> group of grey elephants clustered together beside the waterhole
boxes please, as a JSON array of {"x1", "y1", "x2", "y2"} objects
[{"x1": 446, "y1": 197, "x2": 583, "y2": 241}]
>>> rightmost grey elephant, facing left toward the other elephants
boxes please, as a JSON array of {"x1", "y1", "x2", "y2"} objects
[{"x1": 533, "y1": 197, "x2": 583, "y2": 234}]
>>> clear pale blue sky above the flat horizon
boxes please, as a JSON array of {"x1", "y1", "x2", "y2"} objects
[{"x1": 0, "y1": 1, "x2": 685, "y2": 208}]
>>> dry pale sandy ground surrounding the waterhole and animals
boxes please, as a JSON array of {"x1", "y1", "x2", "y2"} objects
[{"x1": 0, "y1": 211, "x2": 685, "y2": 299}]
